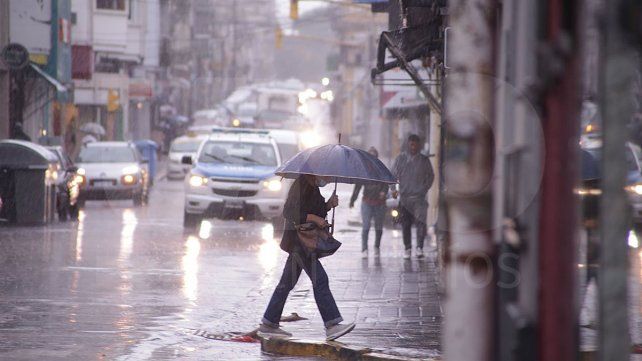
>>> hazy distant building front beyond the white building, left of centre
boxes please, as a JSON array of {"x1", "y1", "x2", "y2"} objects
[{"x1": 161, "y1": 0, "x2": 276, "y2": 116}]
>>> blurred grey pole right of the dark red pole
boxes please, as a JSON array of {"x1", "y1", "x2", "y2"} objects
[{"x1": 598, "y1": 0, "x2": 635, "y2": 361}]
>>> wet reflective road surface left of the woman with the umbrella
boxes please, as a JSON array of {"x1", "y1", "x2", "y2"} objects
[{"x1": 0, "y1": 181, "x2": 318, "y2": 360}]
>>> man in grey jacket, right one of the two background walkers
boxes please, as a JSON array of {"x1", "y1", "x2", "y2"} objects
[{"x1": 392, "y1": 134, "x2": 435, "y2": 259}]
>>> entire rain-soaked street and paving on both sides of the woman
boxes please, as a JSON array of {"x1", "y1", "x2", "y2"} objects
[{"x1": 0, "y1": 175, "x2": 441, "y2": 360}]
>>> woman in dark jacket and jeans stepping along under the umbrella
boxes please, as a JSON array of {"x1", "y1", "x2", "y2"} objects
[{"x1": 258, "y1": 175, "x2": 354, "y2": 341}]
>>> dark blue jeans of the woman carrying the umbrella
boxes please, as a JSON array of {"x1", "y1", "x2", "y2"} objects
[{"x1": 262, "y1": 244, "x2": 343, "y2": 328}]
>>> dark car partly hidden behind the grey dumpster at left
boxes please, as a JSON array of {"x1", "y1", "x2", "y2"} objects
[{"x1": 47, "y1": 146, "x2": 82, "y2": 221}]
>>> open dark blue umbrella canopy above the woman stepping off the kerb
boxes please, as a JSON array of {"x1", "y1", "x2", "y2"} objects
[{"x1": 274, "y1": 144, "x2": 397, "y2": 184}]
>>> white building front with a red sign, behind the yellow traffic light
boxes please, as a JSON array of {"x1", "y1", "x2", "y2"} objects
[{"x1": 72, "y1": 0, "x2": 160, "y2": 140}]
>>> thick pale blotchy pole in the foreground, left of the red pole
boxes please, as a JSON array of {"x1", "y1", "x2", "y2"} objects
[{"x1": 442, "y1": 0, "x2": 497, "y2": 361}]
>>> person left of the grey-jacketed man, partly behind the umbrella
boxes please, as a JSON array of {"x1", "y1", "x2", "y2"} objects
[{"x1": 350, "y1": 147, "x2": 388, "y2": 258}]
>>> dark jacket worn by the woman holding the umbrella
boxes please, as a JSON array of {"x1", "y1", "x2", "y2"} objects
[{"x1": 281, "y1": 177, "x2": 328, "y2": 253}]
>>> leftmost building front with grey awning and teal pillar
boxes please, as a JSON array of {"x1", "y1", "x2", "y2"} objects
[{"x1": 0, "y1": 0, "x2": 73, "y2": 144}]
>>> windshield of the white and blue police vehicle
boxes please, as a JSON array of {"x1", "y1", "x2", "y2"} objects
[{"x1": 198, "y1": 141, "x2": 277, "y2": 166}]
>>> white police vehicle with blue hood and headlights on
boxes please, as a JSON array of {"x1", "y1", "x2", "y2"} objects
[{"x1": 182, "y1": 129, "x2": 292, "y2": 227}]
